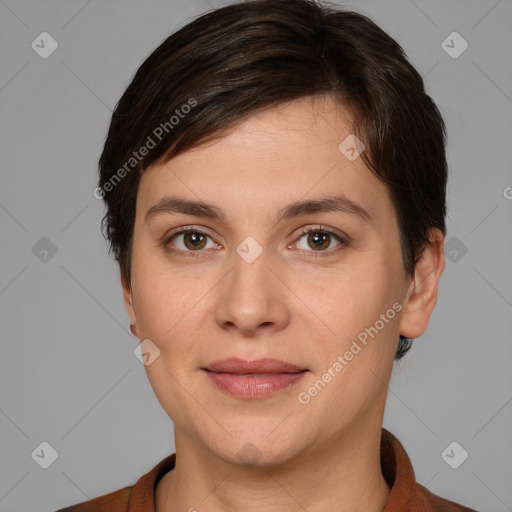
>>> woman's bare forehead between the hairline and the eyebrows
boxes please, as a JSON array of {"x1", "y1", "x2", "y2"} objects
[{"x1": 137, "y1": 96, "x2": 393, "y2": 226}]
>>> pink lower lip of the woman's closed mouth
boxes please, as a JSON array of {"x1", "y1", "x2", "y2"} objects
[{"x1": 205, "y1": 371, "x2": 307, "y2": 398}]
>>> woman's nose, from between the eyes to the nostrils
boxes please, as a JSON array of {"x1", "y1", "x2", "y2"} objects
[{"x1": 215, "y1": 243, "x2": 291, "y2": 337}]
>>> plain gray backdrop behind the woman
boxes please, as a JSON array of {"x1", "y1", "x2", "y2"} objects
[{"x1": 0, "y1": 0, "x2": 512, "y2": 512}]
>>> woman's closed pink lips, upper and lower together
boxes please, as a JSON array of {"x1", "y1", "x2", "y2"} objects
[{"x1": 203, "y1": 358, "x2": 307, "y2": 398}]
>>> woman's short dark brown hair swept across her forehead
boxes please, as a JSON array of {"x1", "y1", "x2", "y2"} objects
[{"x1": 95, "y1": 0, "x2": 447, "y2": 359}]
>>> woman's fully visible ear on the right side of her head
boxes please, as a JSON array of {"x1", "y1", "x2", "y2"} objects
[{"x1": 399, "y1": 228, "x2": 444, "y2": 338}]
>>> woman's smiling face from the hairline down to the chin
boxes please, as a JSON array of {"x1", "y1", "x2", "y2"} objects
[{"x1": 123, "y1": 97, "x2": 435, "y2": 463}]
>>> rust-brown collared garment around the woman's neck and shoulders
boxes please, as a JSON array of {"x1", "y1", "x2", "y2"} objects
[{"x1": 57, "y1": 428, "x2": 476, "y2": 512}]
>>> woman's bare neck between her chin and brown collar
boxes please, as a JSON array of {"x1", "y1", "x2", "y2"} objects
[{"x1": 156, "y1": 426, "x2": 390, "y2": 512}]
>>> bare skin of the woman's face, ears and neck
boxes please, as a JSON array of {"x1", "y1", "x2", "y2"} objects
[{"x1": 122, "y1": 96, "x2": 444, "y2": 512}]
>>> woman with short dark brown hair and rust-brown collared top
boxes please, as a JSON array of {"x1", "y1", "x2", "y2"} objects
[{"x1": 58, "y1": 0, "x2": 478, "y2": 512}]
